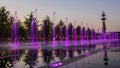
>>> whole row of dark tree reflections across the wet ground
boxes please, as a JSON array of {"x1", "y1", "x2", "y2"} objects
[{"x1": 0, "y1": 44, "x2": 96, "y2": 68}]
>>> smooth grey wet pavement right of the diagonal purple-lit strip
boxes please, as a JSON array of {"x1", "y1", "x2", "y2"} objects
[{"x1": 58, "y1": 48, "x2": 120, "y2": 68}]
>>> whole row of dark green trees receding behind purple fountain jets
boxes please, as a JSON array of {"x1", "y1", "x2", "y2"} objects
[{"x1": 0, "y1": 6, "x2": 95, "y2": 40}]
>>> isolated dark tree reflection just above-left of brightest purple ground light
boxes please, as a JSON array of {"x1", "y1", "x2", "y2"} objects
[{"x1": 42, "y1": 49, "x2": 53, "y2": 64}]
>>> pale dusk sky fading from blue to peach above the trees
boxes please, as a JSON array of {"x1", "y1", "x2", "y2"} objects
[{"x1": 0, "y1": 0, "x2": 120, "y2": 32}]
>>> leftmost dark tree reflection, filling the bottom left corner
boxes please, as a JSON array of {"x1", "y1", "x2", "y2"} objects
[{"x1": 0, "y1": 50, "x2": 19, "y2": 68}]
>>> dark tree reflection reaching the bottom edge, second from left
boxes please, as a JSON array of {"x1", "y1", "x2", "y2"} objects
[{"x1": 23, "y1": 49, "x2": 38, "y2": 68}]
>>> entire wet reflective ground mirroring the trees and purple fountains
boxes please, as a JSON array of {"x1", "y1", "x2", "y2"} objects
[{"x1": 0, "y1": 41, "x2": 120, "y2": 68}]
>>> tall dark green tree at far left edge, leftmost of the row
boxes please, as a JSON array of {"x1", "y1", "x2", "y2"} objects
[{"x1": 0, "y1": 6, "x2": 12, "y2": 40}]
